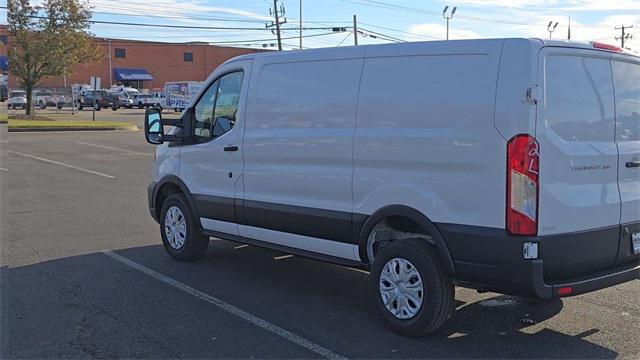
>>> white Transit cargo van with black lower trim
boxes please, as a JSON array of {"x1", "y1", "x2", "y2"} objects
[{"x1": 145, "y1": 39, "x2": 640, "y2": 335}]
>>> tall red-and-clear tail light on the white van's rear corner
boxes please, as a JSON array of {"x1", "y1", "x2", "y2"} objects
[{"x1": 506, "y1": 135, "x2": 540, "y2": 235}]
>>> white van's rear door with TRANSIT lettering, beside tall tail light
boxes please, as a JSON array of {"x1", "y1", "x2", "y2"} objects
[{"x1": 536, "y1": 47, "x2": 620, "y2": 279}]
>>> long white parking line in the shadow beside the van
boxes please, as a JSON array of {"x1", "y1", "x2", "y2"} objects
[{"x1": 102, "y1": 250, "x2": 346, "y2": 360}]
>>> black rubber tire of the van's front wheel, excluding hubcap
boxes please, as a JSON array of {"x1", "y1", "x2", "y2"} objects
[{"x1": 160, "y1": 194, "x2": 209, "y2": 261}]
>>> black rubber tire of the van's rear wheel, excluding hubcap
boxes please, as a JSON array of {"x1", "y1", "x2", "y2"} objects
[{"x1": 370, "y1": 239, "x2": 455, "y2": 336}]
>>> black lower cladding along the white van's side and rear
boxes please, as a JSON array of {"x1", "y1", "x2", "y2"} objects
[{"x1": 148, "y1": 183, "x2": 640, "y2": 298}]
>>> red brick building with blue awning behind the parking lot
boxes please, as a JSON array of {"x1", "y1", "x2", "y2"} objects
[{"x1": 0, "y1": 25, "x2": 263, "y2": 89}]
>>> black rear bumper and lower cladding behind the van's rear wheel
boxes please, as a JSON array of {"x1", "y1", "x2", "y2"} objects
[{"x1": 437, "y1": 222, "x2": 640, "y2": 299}]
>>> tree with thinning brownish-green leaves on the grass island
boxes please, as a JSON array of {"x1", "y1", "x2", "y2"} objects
[{"x1": 7, "y1": 0, "x2": 102, "y2": 115}]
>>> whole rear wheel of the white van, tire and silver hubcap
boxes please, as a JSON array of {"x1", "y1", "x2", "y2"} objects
[{"x1": 370, "y1": 239, "x2": 454, "y2": 336}]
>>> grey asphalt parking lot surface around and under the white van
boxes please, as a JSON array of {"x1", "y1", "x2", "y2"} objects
[{"x1": 0, "y1": 128, "x2": 640, "y2": 359}]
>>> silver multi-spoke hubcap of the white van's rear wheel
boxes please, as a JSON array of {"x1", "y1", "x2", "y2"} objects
[{"x1": 379, "y1": 258, "x2": 424, "y2": 320}]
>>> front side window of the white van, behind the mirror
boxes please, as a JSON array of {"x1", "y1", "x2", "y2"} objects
[{"x1": 193, "y1": 71, "x2": 244, "y2": 140}]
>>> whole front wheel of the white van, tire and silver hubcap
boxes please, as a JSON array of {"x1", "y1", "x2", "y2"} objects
[{"x1": 160, "y1": 194, "x2": 209, "y2": 261}]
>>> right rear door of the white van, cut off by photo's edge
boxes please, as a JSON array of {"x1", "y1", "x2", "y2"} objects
[{"x1": 611, "y1": 54, "x2": 640, "y2": 263}]
